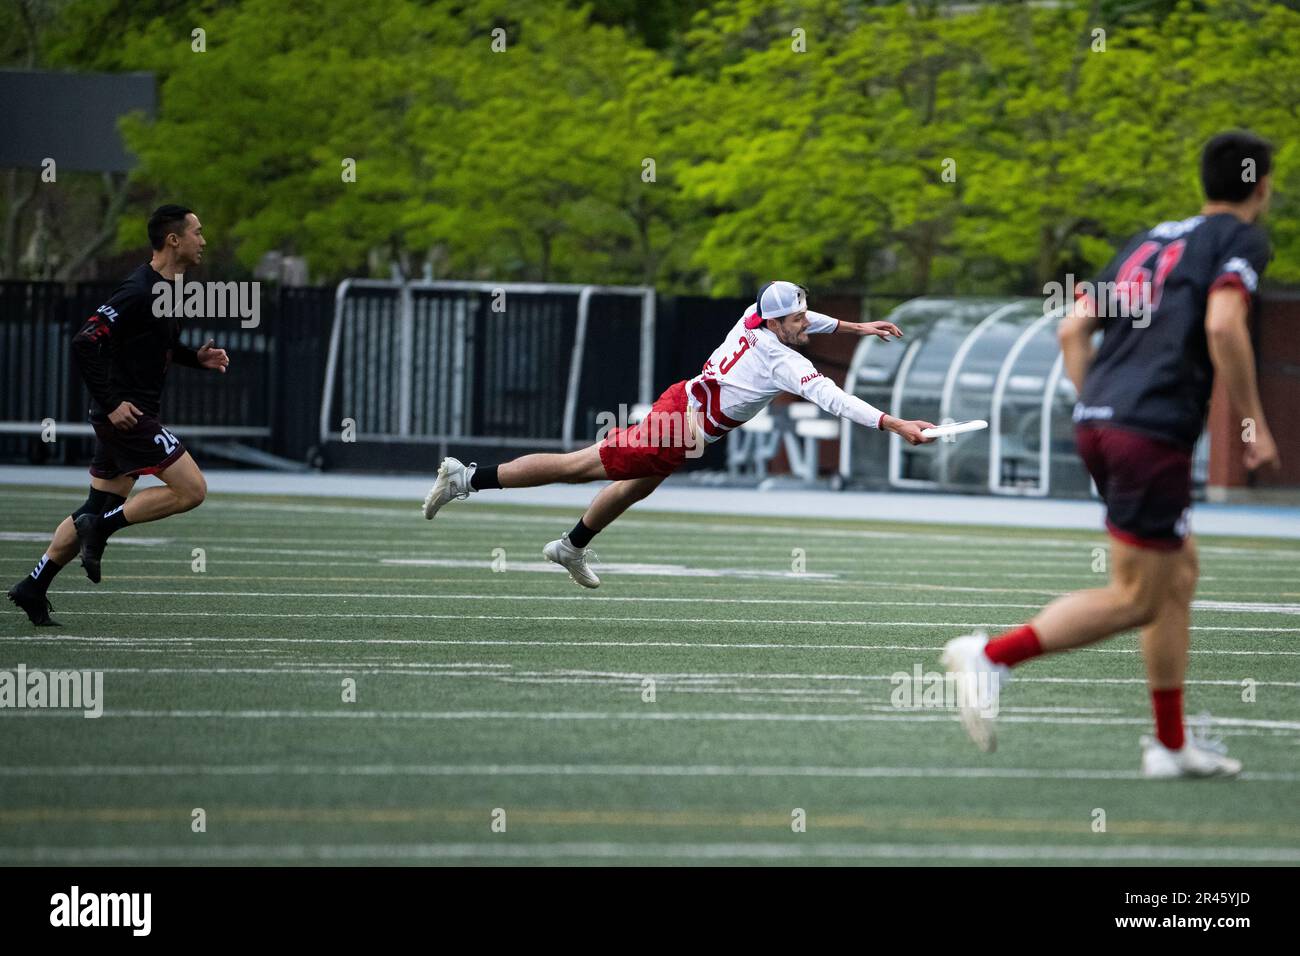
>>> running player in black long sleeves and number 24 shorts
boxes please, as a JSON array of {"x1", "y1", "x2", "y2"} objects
[{"x1": 9, "y1": 206, "x2": 230, "y2": 627}]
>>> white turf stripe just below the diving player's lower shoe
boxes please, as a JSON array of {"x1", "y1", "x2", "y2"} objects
[{"x1": 45, "y1": 587, "x2": 1300, "y2": 614}]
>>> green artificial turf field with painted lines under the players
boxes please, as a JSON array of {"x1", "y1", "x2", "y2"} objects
[{"x1": 0, "y1": 488, "x2": 1300, "y2": 865}]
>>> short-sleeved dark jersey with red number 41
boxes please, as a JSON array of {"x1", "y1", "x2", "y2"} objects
[{"x1": 1074, "y1": 213, "x2": 1270, "y2": 447}]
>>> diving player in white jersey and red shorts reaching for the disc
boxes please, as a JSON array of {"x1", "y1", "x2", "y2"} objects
[{"x1": 424, "y1": 282, "x2": 933, "y2": 588}]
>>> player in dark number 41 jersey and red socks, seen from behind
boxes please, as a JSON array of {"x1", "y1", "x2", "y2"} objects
[{"x1": 944, "y1": 133, "x2": 1278, "y2": 778}]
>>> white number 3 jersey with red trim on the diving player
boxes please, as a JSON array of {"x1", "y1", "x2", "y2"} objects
[{"x1": 686, "y1": 306, "x2": 884, "y2": 442}]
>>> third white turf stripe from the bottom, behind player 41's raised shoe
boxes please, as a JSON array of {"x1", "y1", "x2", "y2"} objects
[{"x1": 0, "y1": 708, "x2": 1300, "y2": 731}]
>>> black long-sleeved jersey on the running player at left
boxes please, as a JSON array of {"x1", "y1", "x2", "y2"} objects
[{"x1": 73, "y1": 263, "x2": 203, "y2": 416}]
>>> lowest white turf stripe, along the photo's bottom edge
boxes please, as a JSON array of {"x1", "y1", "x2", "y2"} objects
[{"x1": 0, "y1": 840, "x2": 1300, "y2": 864}]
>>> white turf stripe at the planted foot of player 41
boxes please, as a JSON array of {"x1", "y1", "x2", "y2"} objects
[{"x1": 0, "y1": 763, "x2": 1300, "y2": 783}]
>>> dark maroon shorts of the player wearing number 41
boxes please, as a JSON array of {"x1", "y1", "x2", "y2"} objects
[{"x1": 1074, "y1": 425, "x2": 1192, "y2": 550}]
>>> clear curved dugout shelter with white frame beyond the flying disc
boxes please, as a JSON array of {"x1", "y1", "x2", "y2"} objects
[{"x1": 840, "y1": 298, "x2": 1092, "y2": 497}]
